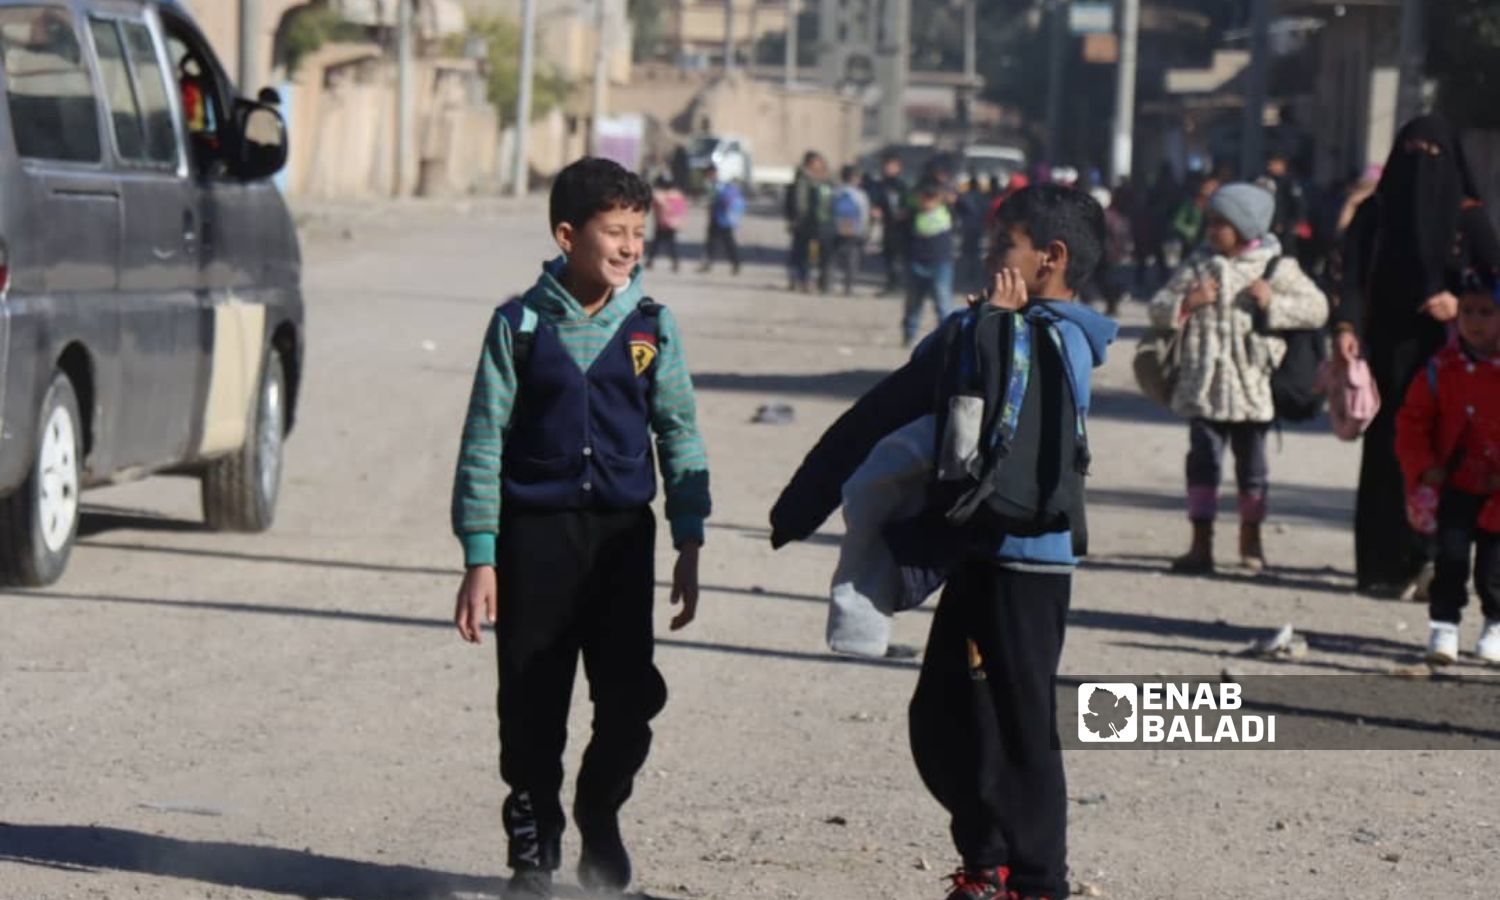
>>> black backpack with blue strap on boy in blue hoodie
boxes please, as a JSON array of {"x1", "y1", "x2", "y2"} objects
[{"x1": 885, "y1": 306, "x2": 1089, "y2": 570}]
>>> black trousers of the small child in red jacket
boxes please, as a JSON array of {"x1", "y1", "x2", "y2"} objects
[{"x1": 1428, "y1": 489, "x2": 1500, "y2": 626}]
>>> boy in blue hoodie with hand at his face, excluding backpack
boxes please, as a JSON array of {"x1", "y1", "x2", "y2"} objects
[{"x1": 771, "y1": 185, "x2": 1116, "y2": 900}]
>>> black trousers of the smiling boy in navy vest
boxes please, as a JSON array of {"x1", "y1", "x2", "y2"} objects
[{"x1": 495, "y1": 507, "x2": 666, "y2": 870}]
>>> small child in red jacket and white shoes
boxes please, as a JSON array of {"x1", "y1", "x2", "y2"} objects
[{"x1": 1397, "y1": 273, "x2": 1500, "y2": 665}]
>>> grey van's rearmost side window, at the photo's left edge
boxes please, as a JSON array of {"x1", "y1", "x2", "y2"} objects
[{"x1": 0, "y1": 6, "x2": 101, "y2": 162}]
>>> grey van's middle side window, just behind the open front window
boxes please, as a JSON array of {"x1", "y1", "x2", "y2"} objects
[{"x1": 89, "y1": 20, "x2": 177, "y2": 167}]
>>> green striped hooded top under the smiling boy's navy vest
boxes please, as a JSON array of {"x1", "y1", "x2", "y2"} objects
[{"x1": 453, "y1": 257, "x2": 711, "y2": 566}]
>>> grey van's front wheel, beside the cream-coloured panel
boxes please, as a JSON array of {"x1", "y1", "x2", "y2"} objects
[{"x1": 201, "y1": 348, "x2": 287, "y2": 533}]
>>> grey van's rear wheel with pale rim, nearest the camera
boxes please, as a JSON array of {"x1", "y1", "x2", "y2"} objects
[{"x1": 0, "y1": 372, "x2": 84, "y2": 588}]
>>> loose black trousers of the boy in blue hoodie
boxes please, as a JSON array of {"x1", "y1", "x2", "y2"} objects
[{"x1": 911, "y1": 561, "x2": 1073, "y2": 899}]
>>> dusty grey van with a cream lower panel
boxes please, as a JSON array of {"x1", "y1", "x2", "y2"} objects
[{"x1": 0, "y1": 0, "x2": 303, "y2": 585}]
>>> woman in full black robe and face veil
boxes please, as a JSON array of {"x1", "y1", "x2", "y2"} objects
[{"x1": 1334, "y1": 116, "x2": 1500, "y2": 599}]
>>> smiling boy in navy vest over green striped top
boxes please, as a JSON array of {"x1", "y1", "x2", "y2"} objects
[{"x1": 453, "y1": 158, "x2": 710, "y2": 899}]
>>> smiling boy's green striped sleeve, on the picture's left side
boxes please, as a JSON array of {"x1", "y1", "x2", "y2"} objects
[{"x1": 453, "y1": 312, "x2": 516, "y2": 567}]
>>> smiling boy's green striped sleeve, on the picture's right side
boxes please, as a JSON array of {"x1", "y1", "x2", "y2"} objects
[{"x1": 651, "y1": 308, "x2": 713, "y2": 549}]
